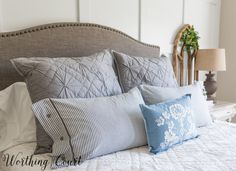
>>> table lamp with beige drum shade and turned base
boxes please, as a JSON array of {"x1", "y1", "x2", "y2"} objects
[{"x1": 195, "y1": 49, "x2": 226, "y2": 101}]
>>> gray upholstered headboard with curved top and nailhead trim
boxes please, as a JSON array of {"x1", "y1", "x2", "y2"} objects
[{"x1": 0, "y1": 23, "x2": 160, "y2": 90}]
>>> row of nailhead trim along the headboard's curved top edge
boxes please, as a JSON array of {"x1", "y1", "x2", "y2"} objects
[{"x1": 0, "y1": 23, "x2": 159, "y2": 48}]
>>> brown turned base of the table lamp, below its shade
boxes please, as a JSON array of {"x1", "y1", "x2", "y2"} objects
[{"x1": 204, "y1": 71, "x2": 217, "y2": 101}]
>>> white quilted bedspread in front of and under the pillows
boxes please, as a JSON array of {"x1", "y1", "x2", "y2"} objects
[{"x1": 0, "y1": 122, "x2": 236, "y2": 171}]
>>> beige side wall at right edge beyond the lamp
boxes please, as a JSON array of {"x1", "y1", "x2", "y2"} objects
[{"x1": 217, "y1": 0, "x2": 236, "y2": 102}]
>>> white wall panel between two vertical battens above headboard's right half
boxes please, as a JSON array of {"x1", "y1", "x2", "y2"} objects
[{"x1": 79, "y1": 0, "x2": 139, "y2": 39}]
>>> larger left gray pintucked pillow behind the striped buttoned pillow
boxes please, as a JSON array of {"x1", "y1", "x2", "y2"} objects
[{"x1": 11, "y1": 50, "x2": 121, "y2": 154}]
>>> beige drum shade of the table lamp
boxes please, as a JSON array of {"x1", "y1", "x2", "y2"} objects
[{"x1": 195, "y1": 49, "x2": 226, "y2": 71}]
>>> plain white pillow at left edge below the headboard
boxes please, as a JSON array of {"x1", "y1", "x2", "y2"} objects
[{"x1": 0, "y1": 82, "x2": 36, "y2": 151}]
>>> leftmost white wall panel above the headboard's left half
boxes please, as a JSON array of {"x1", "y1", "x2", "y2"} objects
[{"x1": 0, "y1": 0, "x2": 78, "y2": 31}]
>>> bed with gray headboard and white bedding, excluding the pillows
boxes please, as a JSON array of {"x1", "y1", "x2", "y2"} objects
[{"x1": 0, "y1": 23, "x2": 236, "y2": 171}]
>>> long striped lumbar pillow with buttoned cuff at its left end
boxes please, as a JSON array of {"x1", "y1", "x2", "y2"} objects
[{"x1": 33, "y1": 88, "x2": 147, "y2": 168}]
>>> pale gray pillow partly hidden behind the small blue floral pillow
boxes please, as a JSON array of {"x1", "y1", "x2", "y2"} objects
[{"x1": 140, "y1": 83, "x2": 212, "y2": 127}]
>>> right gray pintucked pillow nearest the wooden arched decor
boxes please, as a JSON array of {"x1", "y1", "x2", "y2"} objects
[{"x1": 113, "y1": 51, "x2": 178, "y2": 92}]
